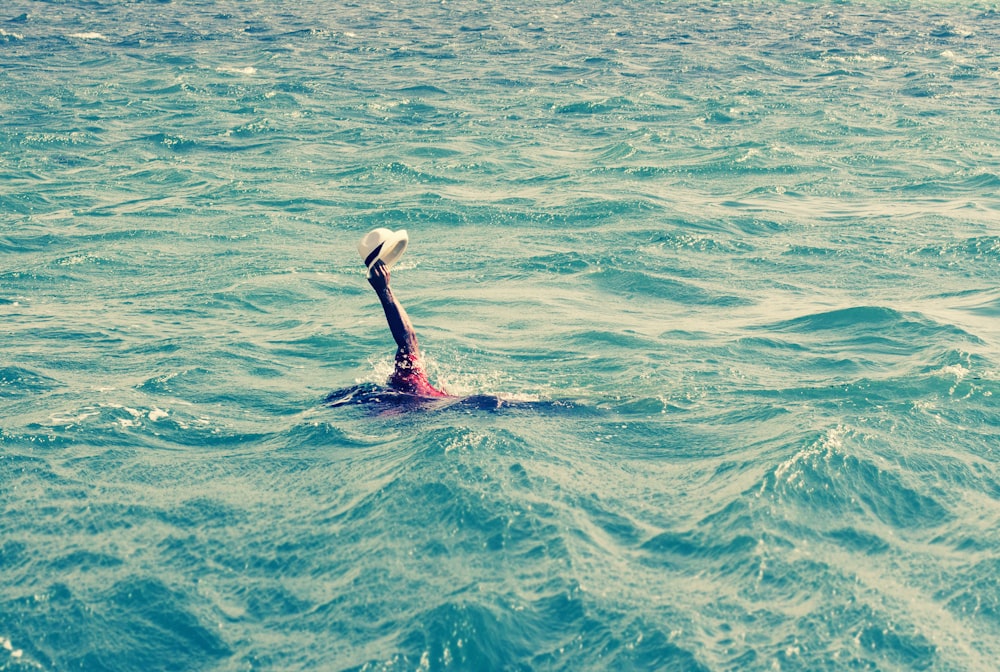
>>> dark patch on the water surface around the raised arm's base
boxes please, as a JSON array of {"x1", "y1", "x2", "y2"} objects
[{"x1": 323, "y1": 383, "x2": 596, "y2": 415}]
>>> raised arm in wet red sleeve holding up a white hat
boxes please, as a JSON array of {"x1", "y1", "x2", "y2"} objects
[{"x1": 358, "y1": 229, "x2": 451, "y2": 397}]
